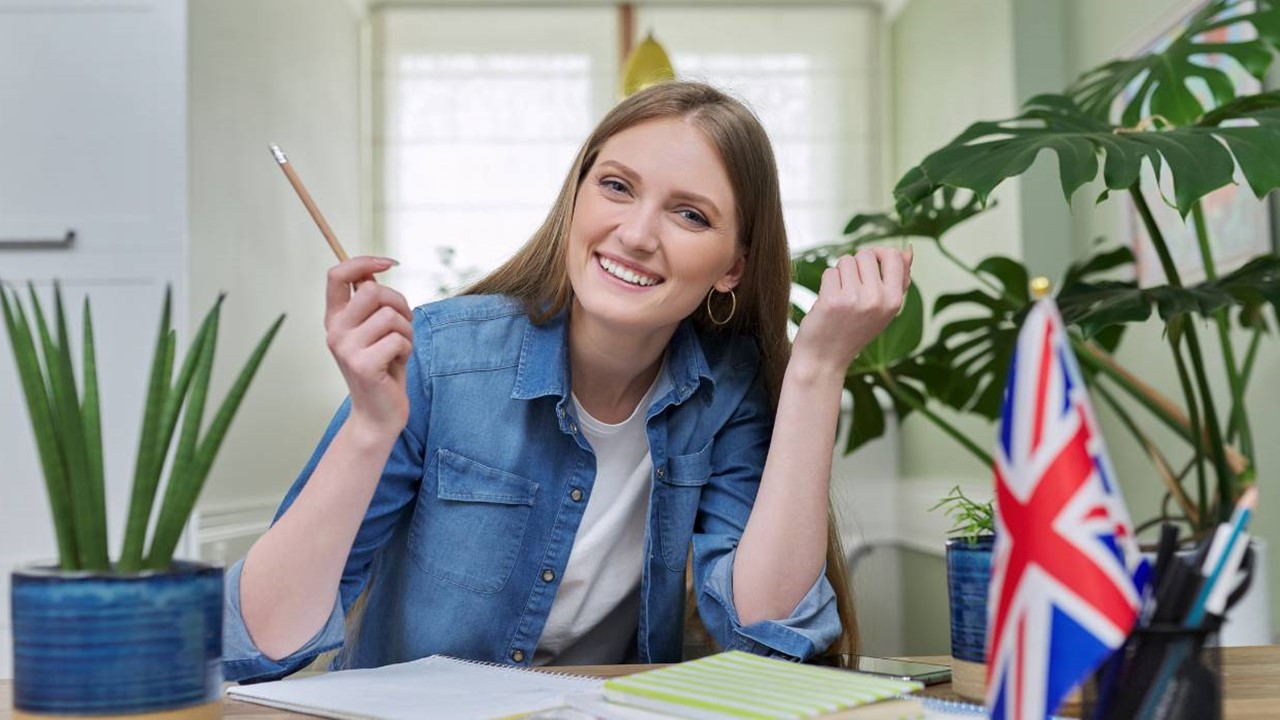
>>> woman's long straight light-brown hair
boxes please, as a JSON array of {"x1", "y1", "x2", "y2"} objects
[{"x1": 462, "y1": 82, "x2": 858, "y2": 652}]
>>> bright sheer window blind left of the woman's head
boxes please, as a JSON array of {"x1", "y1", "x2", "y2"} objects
[{"x1": 374, "y1": 8, "x2": 617, "y2": 305}]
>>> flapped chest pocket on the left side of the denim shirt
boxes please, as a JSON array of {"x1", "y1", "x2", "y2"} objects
[{"x1": 410, "y1": 448, "x2": 538, "y2": 594}]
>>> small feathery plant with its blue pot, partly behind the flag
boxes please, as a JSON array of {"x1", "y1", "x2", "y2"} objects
[{"x1": 931, "y1": 486, "x2": 996, "y2": 700}]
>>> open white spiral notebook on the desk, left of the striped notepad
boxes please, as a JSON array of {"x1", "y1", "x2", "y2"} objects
[{"x1": 227, "y1": 655, "x2": 603, "y2": 720}]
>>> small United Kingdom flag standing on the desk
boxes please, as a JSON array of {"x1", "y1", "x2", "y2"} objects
[{"x1": 987, "y1": 300, "x2": 1146, "y2": 720}]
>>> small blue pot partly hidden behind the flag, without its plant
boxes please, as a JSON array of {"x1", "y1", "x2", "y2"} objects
[{"x1": 947, "y1": 536, "x2": 996, "y2": 662}]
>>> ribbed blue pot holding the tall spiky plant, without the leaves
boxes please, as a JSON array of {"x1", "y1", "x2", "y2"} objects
[{"x1": 12, "y1": 561, "x2": 223, "y2": 716}]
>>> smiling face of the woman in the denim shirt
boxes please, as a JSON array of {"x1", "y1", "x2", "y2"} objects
[{"x1": 567, "y1": 118, "x2": 744, "y2": 332}]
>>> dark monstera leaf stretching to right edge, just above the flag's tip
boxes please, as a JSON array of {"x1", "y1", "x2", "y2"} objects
[{"x1": 1059, "y1": 255, "x2": 1280, "y2": 336}]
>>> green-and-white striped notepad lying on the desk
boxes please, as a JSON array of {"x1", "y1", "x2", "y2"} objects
[{"x1": 604, "y1": 651, "x2": 924, "y2": 720}]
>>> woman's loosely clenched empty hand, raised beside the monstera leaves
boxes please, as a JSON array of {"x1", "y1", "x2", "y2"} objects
[{"x1": 791, "y1": 247, "x2": 911, "y2": 375}]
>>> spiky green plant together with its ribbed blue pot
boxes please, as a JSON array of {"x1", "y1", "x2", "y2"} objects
[{"x1": 0, "y1": 286, "x2": 284, "y2": 719}]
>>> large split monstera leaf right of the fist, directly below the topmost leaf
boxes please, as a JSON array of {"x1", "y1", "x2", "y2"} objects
[{"x1": 893, "y1": 91, "x2": 1280, "y2": 215}]
